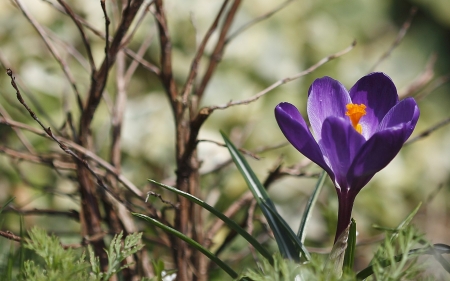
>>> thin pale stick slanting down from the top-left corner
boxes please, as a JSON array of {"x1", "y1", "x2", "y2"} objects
[{"x1": 14, "y1": 0, "x2": 83, "y2": 110}]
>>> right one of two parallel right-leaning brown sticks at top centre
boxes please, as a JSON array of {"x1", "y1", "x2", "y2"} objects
[{"x1": 195, "y1": 0, "x2": 241, "y2": 101}]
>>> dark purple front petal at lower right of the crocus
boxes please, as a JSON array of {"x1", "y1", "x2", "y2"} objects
[{"x1": 347, "y1": 128, "x2": 408, "y2": 196}]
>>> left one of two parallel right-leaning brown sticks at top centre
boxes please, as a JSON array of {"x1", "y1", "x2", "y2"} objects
[{"x1": 181, "y1": 0, "x2": 228, "y2": 104}]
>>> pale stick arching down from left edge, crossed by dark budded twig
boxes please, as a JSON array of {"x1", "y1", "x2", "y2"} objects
[{"x1": 0, "y1": 117, "x2": 144, "y2": 196}]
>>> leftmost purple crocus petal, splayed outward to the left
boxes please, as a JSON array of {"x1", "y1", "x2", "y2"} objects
[{"x1": 275, "y1": 102, "x2": 334, "y2": 175}]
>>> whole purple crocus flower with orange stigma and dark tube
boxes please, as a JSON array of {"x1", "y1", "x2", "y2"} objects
[{"x1": 275, "y1": 73, "x2": 419, "y2": 241}]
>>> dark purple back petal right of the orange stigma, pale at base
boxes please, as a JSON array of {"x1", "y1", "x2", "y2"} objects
[{"x1": 350, "y1": 72, "x2": 398, "y2": 139}]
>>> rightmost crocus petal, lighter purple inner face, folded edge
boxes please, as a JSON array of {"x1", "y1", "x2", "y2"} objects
[{"x1": 378, "y1": 98, "x2": 420, "y2": 142}]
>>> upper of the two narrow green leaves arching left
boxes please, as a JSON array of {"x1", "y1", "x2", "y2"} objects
[{"x1": 149, "y1": 179, "x2": 273, "y2": 264}]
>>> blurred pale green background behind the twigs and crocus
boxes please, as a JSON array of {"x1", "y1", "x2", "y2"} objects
[{"x1": 0, "y1": 0, "x2": 450, "y2": 276}]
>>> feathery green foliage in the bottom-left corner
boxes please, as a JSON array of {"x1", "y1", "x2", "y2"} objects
[{"x1": 20, "y1": 228, "x2": 144, "y2": 281}]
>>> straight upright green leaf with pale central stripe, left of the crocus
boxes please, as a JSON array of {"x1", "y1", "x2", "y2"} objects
[{"x1": 220, "y1": 132, "x2": 300, "y2": 260}]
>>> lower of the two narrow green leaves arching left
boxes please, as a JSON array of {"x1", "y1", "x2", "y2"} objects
[{"x1": 131, "y1": 213, "x2": 239, "y2": 279}]
